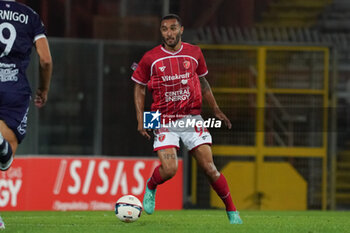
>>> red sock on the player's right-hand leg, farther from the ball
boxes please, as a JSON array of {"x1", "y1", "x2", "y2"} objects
[{"x1": 211, "y1": 174, "x2": 236, "y2": 211}]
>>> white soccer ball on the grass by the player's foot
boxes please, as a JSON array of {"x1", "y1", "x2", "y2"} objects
[{"x1": 115, "y1": 195, "x2": 142, "y2": 222}]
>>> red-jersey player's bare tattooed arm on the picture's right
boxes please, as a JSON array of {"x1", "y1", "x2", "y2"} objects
[{"x1": 199, "y1": 77, "x2": 232, "y2": 129}]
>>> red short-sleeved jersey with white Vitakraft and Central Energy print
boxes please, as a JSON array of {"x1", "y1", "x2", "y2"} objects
[{"x1": 131, "y1": 42, "x2": 208, "y2": 121}]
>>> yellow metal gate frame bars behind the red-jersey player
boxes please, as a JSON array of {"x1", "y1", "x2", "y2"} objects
[{"x1": 192, "y1": 45, "x2": 329, "y2": 210}]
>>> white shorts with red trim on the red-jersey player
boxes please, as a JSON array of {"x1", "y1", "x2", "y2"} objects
[{"x1": 153, "y1": 115, "x2": 212, "y2": 151}]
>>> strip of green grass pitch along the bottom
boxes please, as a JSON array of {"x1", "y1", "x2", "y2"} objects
[{"x1": 1, "y1": 210, "x2": 350, "y2": 233}]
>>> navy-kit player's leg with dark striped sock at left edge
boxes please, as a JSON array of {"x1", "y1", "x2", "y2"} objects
[{"x1": 0, "y1": 120, "x2": 18, "y2": 171}]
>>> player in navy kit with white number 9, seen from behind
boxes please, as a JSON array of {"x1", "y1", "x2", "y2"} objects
[{"x1": 0, "y1": 0, "x2": 52, "y2": 229}]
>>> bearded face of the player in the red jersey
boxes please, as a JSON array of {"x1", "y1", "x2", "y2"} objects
[{"x1": 160, "y1": 19, "x2": 183, "y2": 49}]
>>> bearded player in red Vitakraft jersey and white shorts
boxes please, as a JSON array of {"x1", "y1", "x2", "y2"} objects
[{"x1": 131, "y1": 14, "x2": 242, "y2": 224}]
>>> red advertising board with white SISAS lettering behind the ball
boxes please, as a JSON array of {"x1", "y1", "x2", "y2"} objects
[{"x1": 0, "y1": 157, "x2": 183, "y2": 211}]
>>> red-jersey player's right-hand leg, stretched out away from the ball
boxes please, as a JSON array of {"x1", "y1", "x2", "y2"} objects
[{"x1": 191, "y1": 144, "x2": 242, "y2": 224}]
